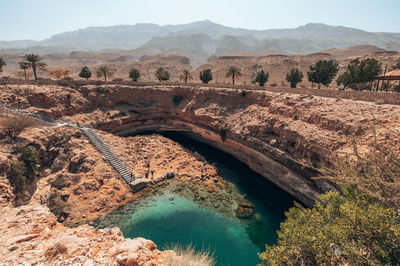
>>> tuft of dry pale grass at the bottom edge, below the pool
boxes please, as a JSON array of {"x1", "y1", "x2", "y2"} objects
[{"x1": 165, "y1": 245, "x2": 216, "y2": 266}]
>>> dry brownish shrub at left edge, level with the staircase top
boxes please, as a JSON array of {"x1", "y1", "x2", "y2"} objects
[{"x1": 0, "y1": 115, "x2": 39, "y2": 138}]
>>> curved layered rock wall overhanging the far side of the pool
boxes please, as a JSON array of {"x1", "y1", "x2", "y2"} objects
[{"x1": 3, "y1": 85, "x2": 400, "y2": 205}]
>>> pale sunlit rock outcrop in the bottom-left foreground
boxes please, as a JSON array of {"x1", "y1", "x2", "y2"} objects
[{"x1": 0, "y1": 205, "x2": 175, "y2": 265}]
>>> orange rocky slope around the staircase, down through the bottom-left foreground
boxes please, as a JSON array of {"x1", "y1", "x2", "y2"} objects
[{"x1": 0, "y1": 120, "x2": 228, "y2": 265}]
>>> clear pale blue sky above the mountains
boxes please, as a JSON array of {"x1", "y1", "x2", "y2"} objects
[{"x1": 0, "y1": 0, "x2": 400, "y2": 40}]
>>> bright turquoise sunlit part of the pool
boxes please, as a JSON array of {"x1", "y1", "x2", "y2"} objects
[{"x1": 121, "y1": 194, "x2": 260, "y2": 265}]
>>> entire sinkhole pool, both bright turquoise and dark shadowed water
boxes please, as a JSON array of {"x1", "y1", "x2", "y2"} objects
[{"x1": 98, "y1": 133, "x2": 294, "y2": 266}]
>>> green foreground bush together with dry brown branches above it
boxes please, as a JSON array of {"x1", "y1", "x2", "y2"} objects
[{"x1": 260, "y1": 130, "x2": 400, "y2": 265}]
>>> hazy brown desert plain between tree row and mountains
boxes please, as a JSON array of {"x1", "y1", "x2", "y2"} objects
[{"x1": 0, "y1": 45, "x2": 400, "y2": 89}]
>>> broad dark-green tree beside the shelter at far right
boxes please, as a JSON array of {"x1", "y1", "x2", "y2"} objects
[{"x1": 336, "y1": 58, "x2": 382, "y2": 90}]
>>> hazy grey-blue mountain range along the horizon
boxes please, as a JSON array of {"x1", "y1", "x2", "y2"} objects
[{"x1": 0, "y1": 20, "x2": 400, "y2": 65}]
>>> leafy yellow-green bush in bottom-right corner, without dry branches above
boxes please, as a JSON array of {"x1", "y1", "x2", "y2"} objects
[{"x1": 260, "y1": 188, "x2": 400, "y2": 265}]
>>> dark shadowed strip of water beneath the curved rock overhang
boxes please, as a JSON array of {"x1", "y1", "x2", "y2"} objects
[{"x1": 160, "y1": 132, "x2": 295, "y2": 245}]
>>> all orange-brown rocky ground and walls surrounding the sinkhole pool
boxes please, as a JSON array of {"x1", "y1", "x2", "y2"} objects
[{"x1": 0, "y1": 81, "x2": 400, "y2": 265}]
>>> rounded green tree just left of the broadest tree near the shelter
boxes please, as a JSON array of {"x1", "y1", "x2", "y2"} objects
[{"x1": 307, "y1": 60, "x2": 339, "y2": 89}]
